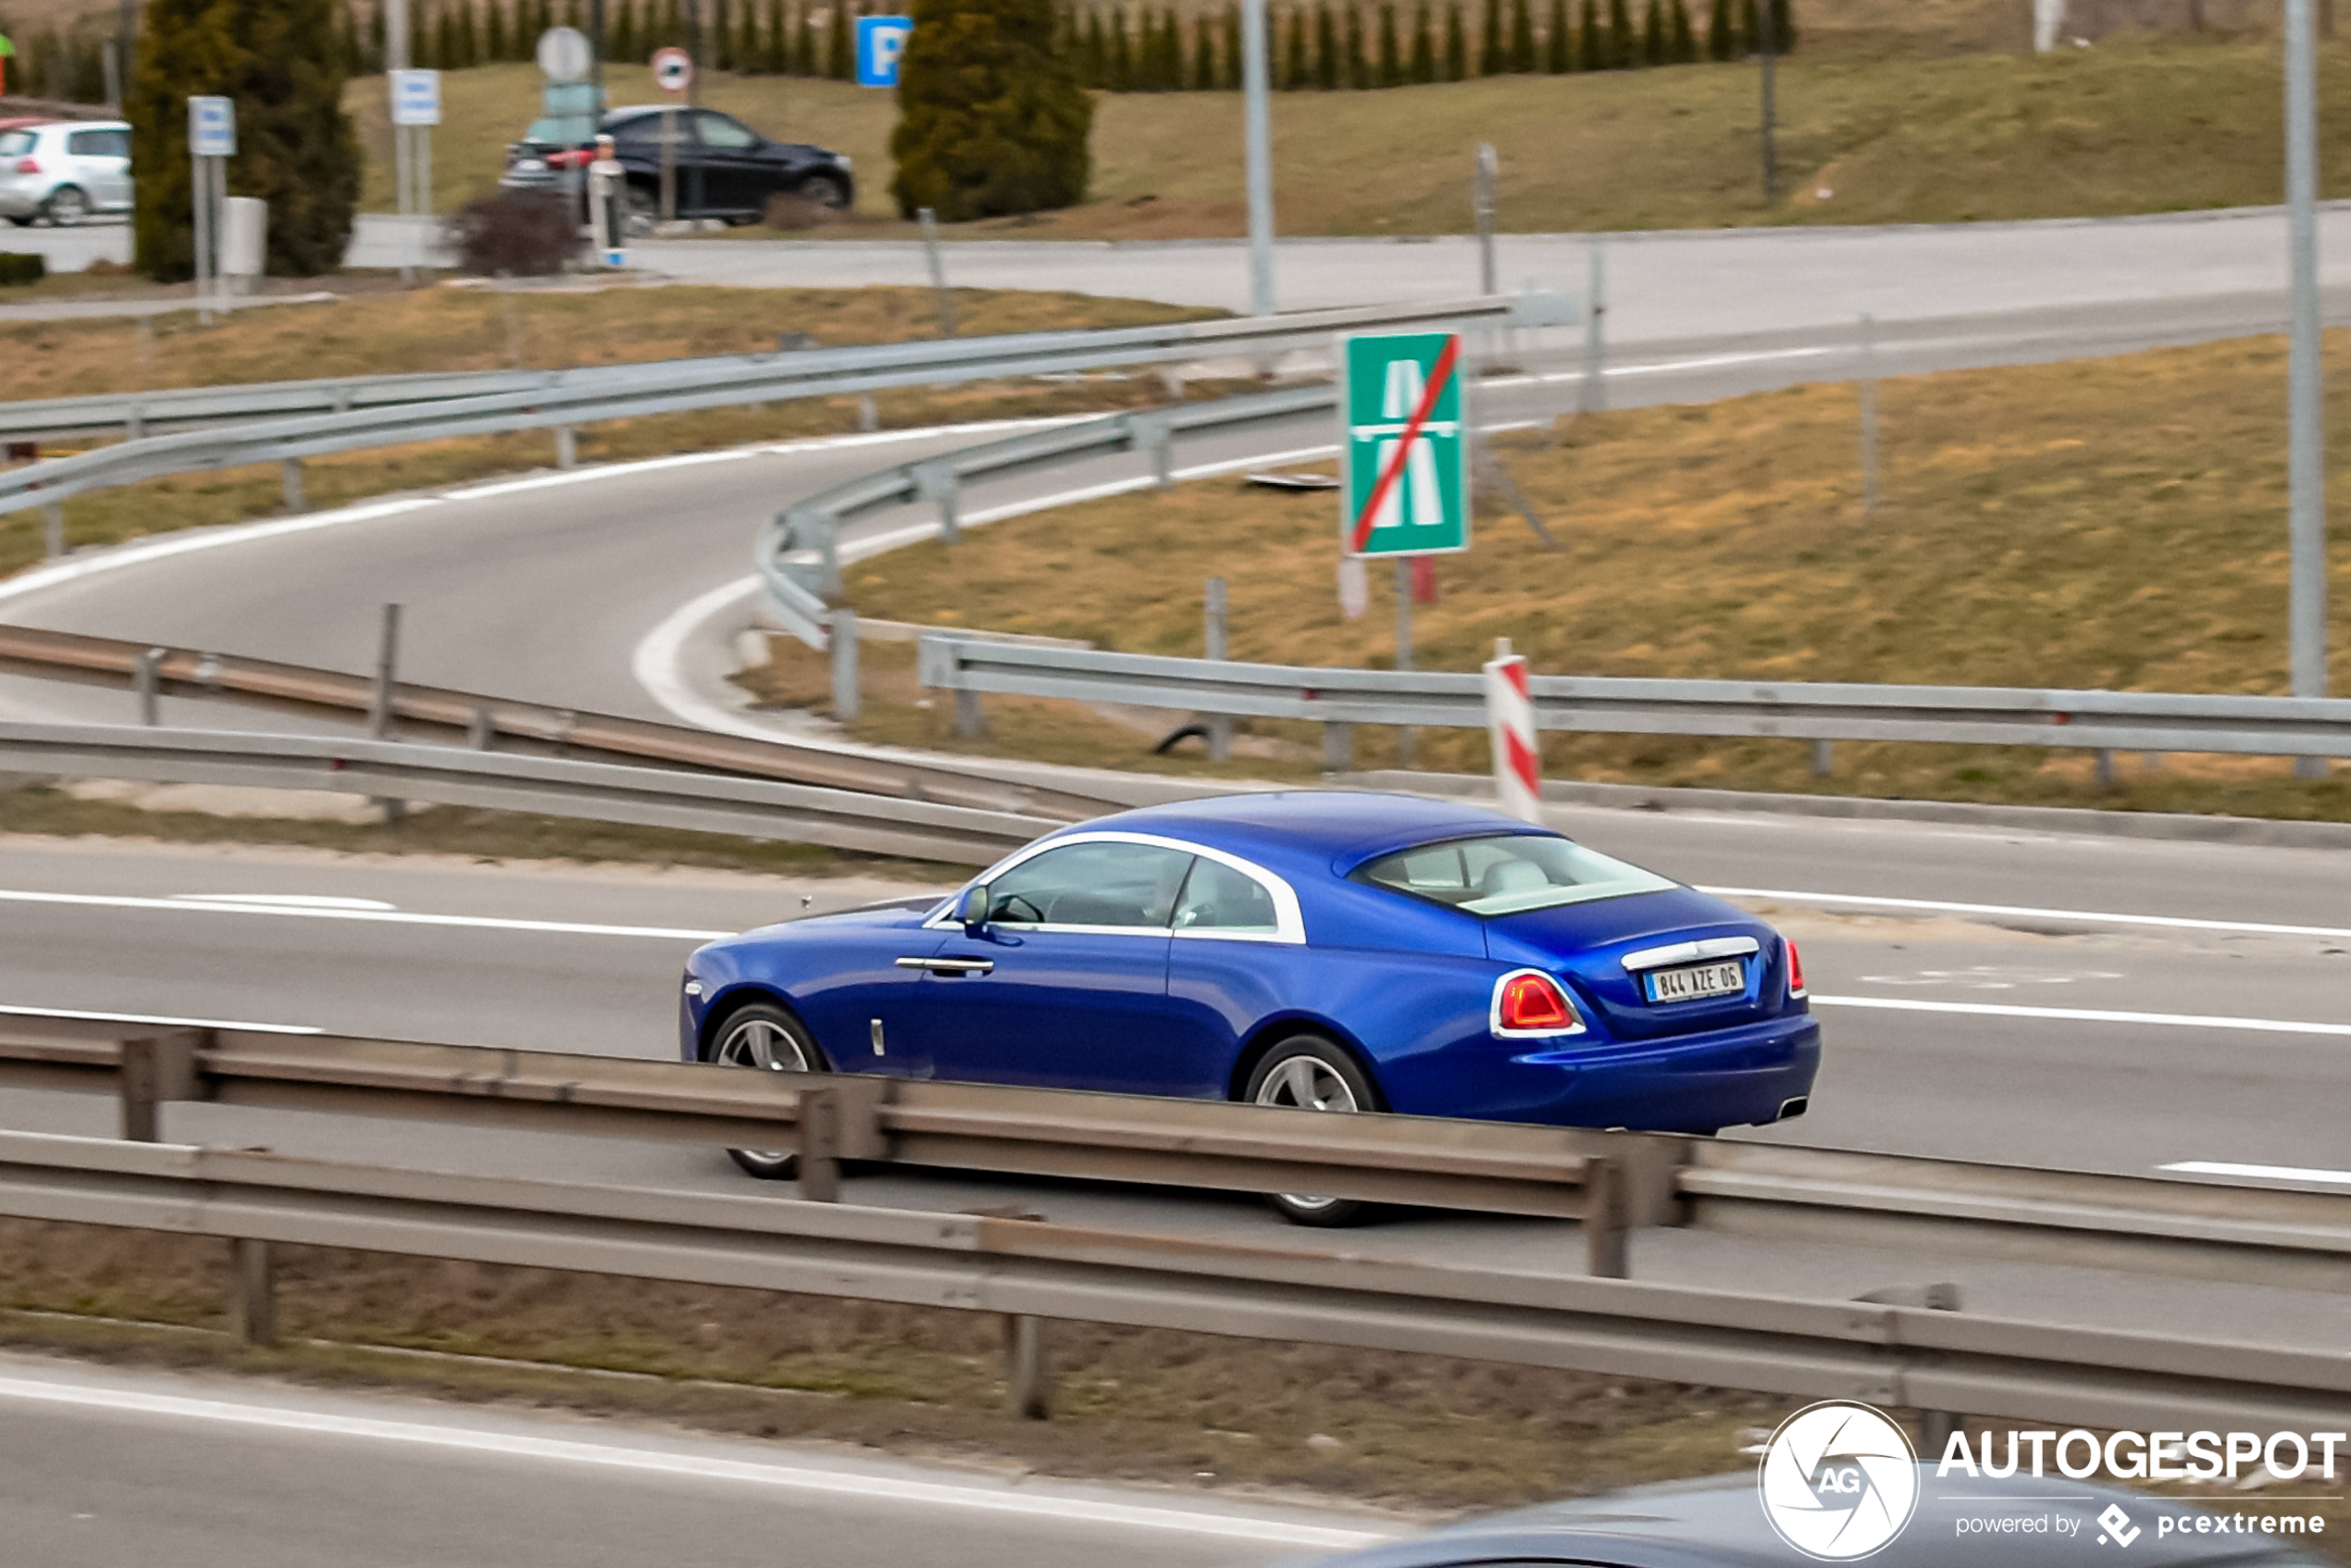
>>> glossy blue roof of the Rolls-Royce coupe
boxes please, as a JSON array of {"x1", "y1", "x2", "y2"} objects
[{"x1": 1084, "y1": 790, "x2": 1549, "y2": 877}]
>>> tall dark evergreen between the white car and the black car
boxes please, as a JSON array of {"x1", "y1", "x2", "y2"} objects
[{"x1": 125, "y1": 0, "x2": 360, "y2": 282}]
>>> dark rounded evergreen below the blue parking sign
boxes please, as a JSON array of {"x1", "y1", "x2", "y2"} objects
[{"x1": 889, "y1": 0, "x2": 1093, "y2": 223}]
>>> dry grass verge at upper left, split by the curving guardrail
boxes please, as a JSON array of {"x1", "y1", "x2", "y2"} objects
[{"x1": 0, "y1": 287, "x2": 1203, "y2": 574}]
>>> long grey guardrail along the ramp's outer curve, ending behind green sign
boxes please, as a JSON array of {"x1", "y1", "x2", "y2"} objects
[{"x1": 0, "y1": 293, "x2": 1573, "y2": 515}]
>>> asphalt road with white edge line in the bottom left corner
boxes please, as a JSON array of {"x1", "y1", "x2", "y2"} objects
[{"x1": 0, "y1": 1356, "x2": 1411, "y2": 1568}]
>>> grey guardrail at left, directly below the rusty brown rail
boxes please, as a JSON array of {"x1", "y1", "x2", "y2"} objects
[{"x1": 0, "y1": 722, "x2": 1061, "y2": 865}]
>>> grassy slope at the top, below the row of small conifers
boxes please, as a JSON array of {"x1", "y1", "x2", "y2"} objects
[{"x1": 350, "y1": 38, "x2": 2351, "y2": 240}]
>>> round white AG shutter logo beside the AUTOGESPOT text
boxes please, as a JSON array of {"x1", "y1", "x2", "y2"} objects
[{"x1": 1756, "y1": 1399, "x2": 1919, "y2": 1563}]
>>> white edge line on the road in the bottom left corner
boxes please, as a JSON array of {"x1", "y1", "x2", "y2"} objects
[{"x1": 0, "y1": 1377, "x2": 1392, "y2": 1551}]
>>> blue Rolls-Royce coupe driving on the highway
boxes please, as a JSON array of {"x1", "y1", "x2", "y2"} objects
[{"x1": 682, "y1": 790, "x2": 1820, "y2": 1223}]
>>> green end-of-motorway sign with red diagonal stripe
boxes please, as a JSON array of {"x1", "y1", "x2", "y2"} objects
[{"x1": 1340, "y1": 331, "x2": 1470, "y2": 554}]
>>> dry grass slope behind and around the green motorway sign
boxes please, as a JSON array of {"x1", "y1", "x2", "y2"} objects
[{"x1": 743, "y1": 339, "x2": 2351, "y2": 818}]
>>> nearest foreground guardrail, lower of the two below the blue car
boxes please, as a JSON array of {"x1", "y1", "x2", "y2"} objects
[{"x1": 0, "y1": 1133, "x2": 2351, "y2": 1432}]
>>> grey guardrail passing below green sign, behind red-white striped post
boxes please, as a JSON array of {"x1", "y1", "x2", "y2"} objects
[{"x1": 917, "y1": 632, "x2": 2351, "y2": 766}]
